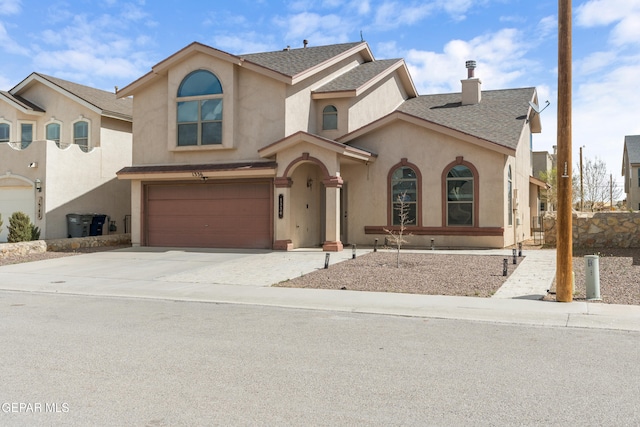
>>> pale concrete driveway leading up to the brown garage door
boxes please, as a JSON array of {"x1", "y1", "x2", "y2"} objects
[{"x1": 0, "y1": 247, "x2": 368, "y2": 293}]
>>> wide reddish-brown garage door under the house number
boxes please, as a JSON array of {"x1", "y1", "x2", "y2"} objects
[{"x1": 145, "y1": 181, "x2": 272, "y2": 249}]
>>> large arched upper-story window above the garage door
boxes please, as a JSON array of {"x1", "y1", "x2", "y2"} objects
[{"x1": 177, "y1": 70, "x2": 222, "y2": 147}]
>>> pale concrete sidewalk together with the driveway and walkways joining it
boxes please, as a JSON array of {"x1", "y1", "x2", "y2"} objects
[{"x1": 0, "y1": 248, "x2": 640, "y2": 331}]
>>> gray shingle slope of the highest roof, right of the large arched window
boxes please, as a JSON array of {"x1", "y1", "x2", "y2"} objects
[{"x1": 238, "y1": 42, "x2": 364, "y2": 77}]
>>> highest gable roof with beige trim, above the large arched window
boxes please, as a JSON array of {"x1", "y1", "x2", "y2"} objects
[{"x1": 117, "y1": 42, "x2": 374, "y2": 96}]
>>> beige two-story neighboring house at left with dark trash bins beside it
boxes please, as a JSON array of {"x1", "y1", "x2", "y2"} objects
[{"x1": 0, "y1": 73, "x2": 133, "y2": 242}]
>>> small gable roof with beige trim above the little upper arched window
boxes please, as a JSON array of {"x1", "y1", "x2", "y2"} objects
[{"x1": 312, "y1": 58, "x2": 418, "y2": 99}]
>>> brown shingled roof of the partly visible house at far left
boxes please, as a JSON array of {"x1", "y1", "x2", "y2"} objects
[{"x1": 11, "y1": 73, "x2": 133, "y2": 121}]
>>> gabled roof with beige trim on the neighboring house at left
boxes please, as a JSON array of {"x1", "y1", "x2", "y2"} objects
[{"x1": 9, "y1": 73, "x2": 133, "y2": 121}]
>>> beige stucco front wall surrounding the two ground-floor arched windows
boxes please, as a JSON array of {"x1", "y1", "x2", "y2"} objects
[{"x1": 342, "y1": 122, "x2": 505, "y2": 244}]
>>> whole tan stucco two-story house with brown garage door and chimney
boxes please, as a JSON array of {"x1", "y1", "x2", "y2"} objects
[{"x1": 117, "y1": 42, "x2": 543, "y2": 251}]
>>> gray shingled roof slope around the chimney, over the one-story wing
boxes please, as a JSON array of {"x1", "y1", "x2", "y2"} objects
[{"x1": 397, "y1": 87, "x2": 535, "y2": 150}]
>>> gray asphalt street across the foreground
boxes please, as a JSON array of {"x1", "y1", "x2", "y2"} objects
[{"x1": 0, "y1": 291, "x2": 640, "y2": 426}]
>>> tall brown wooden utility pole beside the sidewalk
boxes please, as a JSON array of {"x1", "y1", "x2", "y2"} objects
[{"x1": 556, "y1": 0, "x2": 573, "y2": 302}]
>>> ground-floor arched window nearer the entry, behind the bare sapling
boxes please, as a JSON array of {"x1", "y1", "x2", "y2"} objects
[{"x1": 389, "y1": 165, "x2": 419, "y2": 225}]
